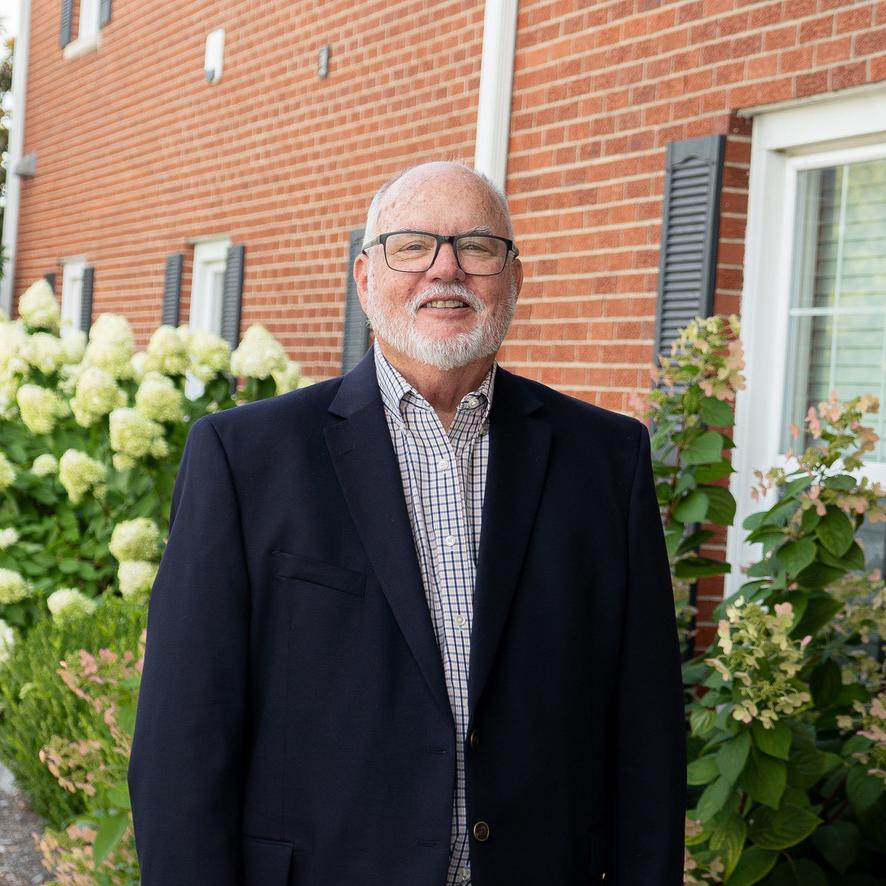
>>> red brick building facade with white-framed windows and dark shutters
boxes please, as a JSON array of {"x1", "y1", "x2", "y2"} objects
[{"x1": 4, "y1": 0, "x2": 886, "y2": 640}]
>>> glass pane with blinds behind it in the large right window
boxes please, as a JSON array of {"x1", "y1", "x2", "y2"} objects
[{"x1": 782, "y1": 159, "x2": 886, "y2": 462}]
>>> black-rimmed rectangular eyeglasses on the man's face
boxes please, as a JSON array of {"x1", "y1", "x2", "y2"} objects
[{"x1": 363, "y1": 231, "x2": 520, "y2": 277}]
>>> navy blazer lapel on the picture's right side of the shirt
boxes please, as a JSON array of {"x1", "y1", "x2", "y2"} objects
[{"x1": 468, "y1": 367, "x2": 551, "y2": 717}]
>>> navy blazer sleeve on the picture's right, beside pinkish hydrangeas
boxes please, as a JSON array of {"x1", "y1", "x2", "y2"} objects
[{"x1": 607, "y1": 425, "x2": 686, "y2": 886}]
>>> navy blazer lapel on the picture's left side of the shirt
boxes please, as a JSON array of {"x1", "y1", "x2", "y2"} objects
[{"x1": 325, "y1": 350, "x2": 451, "y2": 716}]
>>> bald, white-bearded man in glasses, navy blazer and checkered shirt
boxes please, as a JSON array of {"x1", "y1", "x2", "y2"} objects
[{"x1": 130, "y1": 163, "x2": 685, "y2": 886}]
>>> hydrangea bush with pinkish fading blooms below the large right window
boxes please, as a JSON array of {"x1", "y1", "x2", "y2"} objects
[{"x1": 637, "y1": 317, "x2": 886, "y2": 886}]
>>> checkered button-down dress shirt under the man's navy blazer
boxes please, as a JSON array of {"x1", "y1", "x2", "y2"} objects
[{"x1": 375, "y1": 343, "x2": 495, "y2": 886}]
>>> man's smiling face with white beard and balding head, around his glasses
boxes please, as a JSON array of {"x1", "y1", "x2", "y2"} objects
[{"x1": 354, "y1": 165, "x2": 523, "y2": 370}]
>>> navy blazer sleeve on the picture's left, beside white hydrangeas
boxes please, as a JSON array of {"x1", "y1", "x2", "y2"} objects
[{"x1": 129, "y1": 417, "x2": 249, "y2": 886}]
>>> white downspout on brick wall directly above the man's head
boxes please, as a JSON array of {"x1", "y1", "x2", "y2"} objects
[{"x1": 474, "y1": 0, "x2": 519, "y2": 190}]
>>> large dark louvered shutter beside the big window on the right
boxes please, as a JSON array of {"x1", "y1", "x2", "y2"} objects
[{"x1": 653, "y1": 135, "x2": 726, "y2": 359}]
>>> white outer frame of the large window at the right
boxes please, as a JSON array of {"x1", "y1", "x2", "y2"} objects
[{"x1": 725, "y1": 87, "x2": 886, "y2": 596}]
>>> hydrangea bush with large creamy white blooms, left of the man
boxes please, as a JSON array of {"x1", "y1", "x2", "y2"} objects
[{"x1": 0, "y1": 280, "x2": 310, "y2": 659}]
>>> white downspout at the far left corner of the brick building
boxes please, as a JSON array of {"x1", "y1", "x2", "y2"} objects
[{"x1": 0, "y1": 0, "x2": 31, "y2": 317}]
